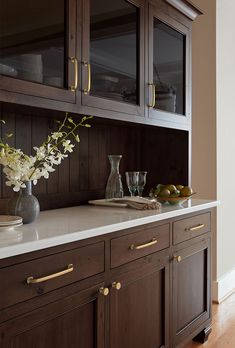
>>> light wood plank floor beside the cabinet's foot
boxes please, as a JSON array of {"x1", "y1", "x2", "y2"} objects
[{"x1": 185, "y1": 294, "x2": 235, "y2": 348}]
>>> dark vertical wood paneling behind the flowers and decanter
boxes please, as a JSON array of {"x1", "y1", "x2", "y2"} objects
[{"x1": 0, "y1": 103, "x2": 188, "y2": 212}]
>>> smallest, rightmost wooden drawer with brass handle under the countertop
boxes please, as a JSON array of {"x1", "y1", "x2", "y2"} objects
[{"x1": 173, "y1": 213, "x2": 211, "y2": 244}]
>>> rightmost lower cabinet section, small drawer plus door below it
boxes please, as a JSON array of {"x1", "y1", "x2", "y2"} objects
[{"x1": 172, "y1": 213, "x2": 211, "y2": 347}]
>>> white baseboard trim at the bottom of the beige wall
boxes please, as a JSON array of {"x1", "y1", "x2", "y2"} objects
[{"x1": 212, "y1": 268, "x2": 235, "y2": 303}]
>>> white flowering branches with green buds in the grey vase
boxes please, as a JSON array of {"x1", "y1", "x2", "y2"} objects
[{"x1": 0, "y1": 114, "x2": 92, "y2": 192}]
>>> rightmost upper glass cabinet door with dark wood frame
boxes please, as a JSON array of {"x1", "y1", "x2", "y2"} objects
[{"x1": 149, "y1": 6, "x2": 190, "y2": 126}]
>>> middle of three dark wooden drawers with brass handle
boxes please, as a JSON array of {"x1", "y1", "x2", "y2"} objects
[{"x1": 111, "y1": 224, "x2": 170, "y2": 268}]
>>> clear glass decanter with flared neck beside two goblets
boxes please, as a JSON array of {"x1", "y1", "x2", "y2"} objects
[{"x1": 105, "y1": 155, "x2": 123, "y2": 199}]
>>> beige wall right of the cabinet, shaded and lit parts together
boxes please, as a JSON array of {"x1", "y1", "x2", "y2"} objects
[{"x1": 192, "y1": 0, "x2": 235, "y2": 300}]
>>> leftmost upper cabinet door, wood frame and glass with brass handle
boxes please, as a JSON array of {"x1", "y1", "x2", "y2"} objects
[{"x1": 0, "y1": 0, "x2": 79, "y2": 106}]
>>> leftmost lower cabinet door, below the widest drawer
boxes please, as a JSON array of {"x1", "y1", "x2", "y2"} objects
[{"x1": 0, "y1": 284, "x2": 106, "y2": 348}]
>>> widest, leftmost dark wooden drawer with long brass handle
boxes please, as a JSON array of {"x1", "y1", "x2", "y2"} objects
[{"x1": 0, "y1": 242, "x2": 104, "y2": 309}]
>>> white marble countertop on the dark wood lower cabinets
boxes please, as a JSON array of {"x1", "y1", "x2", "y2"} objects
[{"x1": 0, "y1": 199, "x2": 219, "y2": 259}]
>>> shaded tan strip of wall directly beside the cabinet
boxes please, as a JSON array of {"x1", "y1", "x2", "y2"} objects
[{"x1": 192, "y1": 0, "x2": 217, "y2": 279}]
